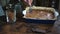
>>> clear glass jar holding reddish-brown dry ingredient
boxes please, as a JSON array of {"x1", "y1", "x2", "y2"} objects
[{"x1": 6, "y1": 4, "x2": 16, "y2": 23}]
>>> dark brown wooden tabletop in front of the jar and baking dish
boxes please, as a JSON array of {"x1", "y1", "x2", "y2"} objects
[{"x1": 0, "y1": 20, "x2": 53, "y2": 34}]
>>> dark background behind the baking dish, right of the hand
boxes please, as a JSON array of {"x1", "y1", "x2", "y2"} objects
[{"x1": 34, "y1": 0, "x2": 59, "y2": 9}]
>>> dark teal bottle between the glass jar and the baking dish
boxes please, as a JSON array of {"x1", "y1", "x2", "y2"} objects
[{"x1": 14, "y1": 0, "x2": 23, "y2": 20}]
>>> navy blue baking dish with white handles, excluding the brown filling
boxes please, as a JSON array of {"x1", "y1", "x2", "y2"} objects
[{"x1": 23, "y1": 7, "x2": 59, "y2": 24}]
